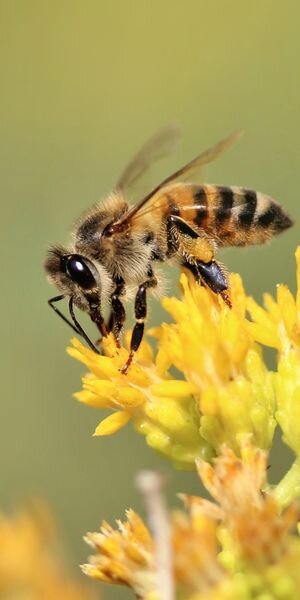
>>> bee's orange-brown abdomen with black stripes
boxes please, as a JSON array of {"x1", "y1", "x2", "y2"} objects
[{"x1": 161, "y1": 184, "x2": 292, "y2": 246}]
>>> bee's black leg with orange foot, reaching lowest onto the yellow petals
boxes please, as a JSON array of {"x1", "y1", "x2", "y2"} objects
[{"x1": 120, "y1": 267, "x2": 157, "y2": 375}]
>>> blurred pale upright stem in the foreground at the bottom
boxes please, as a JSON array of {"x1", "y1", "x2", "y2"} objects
[{"x1": 137, "y1": 471, "x2": 175, "y2": 600}]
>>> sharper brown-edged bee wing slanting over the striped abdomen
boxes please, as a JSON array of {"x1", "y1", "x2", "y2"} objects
[{"x1": 116, "y1": 131, "x2": 241, "y2": 230}]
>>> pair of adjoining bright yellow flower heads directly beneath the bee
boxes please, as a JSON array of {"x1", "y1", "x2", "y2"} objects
[{"x1": 68, "y1": 274, "x2": 275, "y2": 467}]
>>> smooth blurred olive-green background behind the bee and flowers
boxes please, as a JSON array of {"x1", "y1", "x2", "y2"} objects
[{"x1": 0, "y1": 0, "x2": 300, "y2": 599}]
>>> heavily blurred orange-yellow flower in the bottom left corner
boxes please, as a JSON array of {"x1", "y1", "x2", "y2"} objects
[{"x1": 0, "y1": 504, "x2": 95, "y2": 600}]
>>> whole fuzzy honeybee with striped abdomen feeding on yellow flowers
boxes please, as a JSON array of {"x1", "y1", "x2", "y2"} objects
[{"x1": 45, "y1": 128, "x2": 292, "y2": 374}]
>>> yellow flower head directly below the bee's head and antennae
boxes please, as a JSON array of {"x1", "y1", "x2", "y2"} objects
[{"x1": 68, "y1": 336, "x2": 206, "y2": 466}]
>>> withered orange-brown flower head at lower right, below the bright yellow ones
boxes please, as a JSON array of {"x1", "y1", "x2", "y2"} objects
[{"x1": 197, "y1": 444, "x2": 299, "y2": 566}]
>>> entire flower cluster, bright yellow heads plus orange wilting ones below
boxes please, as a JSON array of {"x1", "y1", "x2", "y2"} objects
[{"x1": 69, "y1": 248, "x2": 300, "y2": 600}]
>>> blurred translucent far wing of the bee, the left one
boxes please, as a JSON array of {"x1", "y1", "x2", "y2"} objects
[{"x1": 117, "y1": 125, "x2": 180, "y2": 191}]
